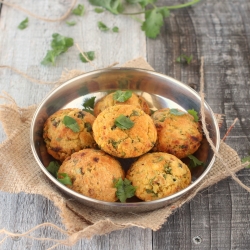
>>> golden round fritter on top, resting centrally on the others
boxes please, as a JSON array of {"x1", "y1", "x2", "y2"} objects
[{"x1": 93, "y1": 105, "x2": 157, "y2": 158}]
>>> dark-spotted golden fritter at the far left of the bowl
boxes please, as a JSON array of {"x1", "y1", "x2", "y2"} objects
[{"x1": 43, "y1": 108, "x2": 96, "y2": 161}]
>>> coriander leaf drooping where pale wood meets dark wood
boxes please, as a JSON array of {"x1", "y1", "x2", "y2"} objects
[{"x1": 141, "y1": 8, "x2": 163, "y2": 38}]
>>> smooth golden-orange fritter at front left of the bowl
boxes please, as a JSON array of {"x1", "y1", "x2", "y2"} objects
[{"x1": 58, "y1": 149, "x2": 124, "y2": 202}]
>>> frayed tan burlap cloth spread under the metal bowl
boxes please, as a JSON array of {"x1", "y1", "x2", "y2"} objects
[{"x1": 0, "y1": 58, "x2": 246, "y2": 245}]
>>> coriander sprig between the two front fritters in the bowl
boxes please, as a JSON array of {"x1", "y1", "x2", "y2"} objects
[{"x1": 115, "y1": 178, "x2": 136, "y2": 202}]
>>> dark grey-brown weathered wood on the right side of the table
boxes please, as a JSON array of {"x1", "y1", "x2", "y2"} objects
[{"x1": 147, "y1": 0, "x2": 250, "y2": 249}]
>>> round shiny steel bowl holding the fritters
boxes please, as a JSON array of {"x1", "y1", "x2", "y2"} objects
[{"x1": 30, "y1": 68, "x2": 220, "y2": 213}]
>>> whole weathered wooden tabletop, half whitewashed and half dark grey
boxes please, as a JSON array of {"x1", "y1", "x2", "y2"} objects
[{"x1": 0, "y1": 0, "x2": 250, "y2": 250}]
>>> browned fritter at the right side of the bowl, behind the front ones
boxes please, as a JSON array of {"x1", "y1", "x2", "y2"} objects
[{"x1": 152, "y1": 108, "x2": 202, "y2": 159}]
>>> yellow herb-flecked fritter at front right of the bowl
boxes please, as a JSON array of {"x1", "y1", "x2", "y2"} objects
[{"x1": 126, "y1": 152, "x2": 191, "y2": 201}]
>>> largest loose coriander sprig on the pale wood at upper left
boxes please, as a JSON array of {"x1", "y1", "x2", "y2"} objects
[{"x1": 41, "y1": 33, "x2": 74, "y2": 65}]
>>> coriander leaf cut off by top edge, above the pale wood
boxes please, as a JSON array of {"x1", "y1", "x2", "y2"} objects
[{"x1": 89, "y1": 0, "x2": 124, "y2": 15}]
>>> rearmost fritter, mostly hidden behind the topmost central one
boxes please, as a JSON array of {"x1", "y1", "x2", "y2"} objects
[{"x1": 94, "y1": 92, "x2": 150, "y2": 116}]
